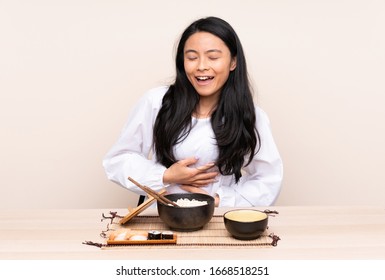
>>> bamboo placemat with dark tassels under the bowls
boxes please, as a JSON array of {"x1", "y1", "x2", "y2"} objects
[{"x1": 96, "y1": 215, "x2": 280, "y2": 249}]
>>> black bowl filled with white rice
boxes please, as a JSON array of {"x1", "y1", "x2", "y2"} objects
[{"x1": 157, "y1": 193, "x2": 215, "y2": 231}]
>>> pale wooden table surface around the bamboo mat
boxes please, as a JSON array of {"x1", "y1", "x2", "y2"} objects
[{"x1": 0, "y1": 206, "x2": 385, "y2": 260}]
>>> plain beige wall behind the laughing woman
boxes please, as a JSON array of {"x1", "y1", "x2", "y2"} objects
[{"x1": 0, "y1": 0, "x2": 385, "y2": 208}]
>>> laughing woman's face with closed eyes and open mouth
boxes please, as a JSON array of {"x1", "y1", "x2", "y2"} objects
[{"x1": 184, "y1": 32, "x2": 236, "y2": 100}]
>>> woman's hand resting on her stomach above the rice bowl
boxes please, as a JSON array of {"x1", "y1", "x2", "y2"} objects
[{"x1": 163, "y1": 157, "x2": 218, "y2": 187}]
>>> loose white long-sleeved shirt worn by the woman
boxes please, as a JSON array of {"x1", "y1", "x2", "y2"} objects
[{"x1": 103, "y1": 87, "x2": 283, "y2": 207}]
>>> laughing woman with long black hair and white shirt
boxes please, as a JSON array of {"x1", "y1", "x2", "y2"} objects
[{"x1": 103, "y1": 17, "x2": 283, "y2": 207}]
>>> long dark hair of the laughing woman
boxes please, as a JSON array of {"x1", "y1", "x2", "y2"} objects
[{"x1": 153, "y1": 17, "x2": 260, "y2": 182}]
